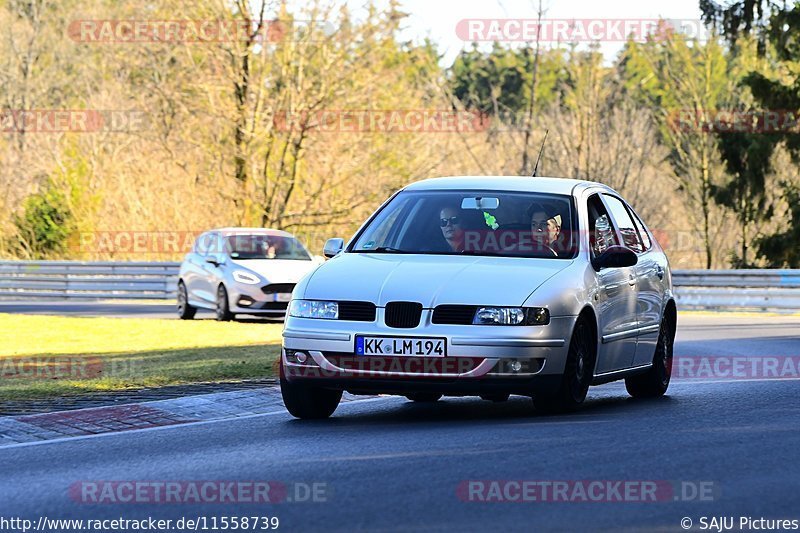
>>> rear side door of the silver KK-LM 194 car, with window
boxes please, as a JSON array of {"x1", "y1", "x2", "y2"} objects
[{"x1": 627, "y1": 206, "x2": 667, "y2": 366}]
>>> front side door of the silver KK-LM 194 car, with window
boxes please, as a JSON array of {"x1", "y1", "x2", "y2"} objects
[{"x1": 588, "y1": 194, "x2": 638, "y2": 374}]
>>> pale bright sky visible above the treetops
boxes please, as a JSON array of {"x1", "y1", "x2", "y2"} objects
[{"x1": 347, "y1": 0, "x2": 700, "y2": 65}]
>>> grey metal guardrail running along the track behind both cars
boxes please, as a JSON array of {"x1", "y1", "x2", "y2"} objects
[{"x1": 0, "y1": 261, "x2": 800, "y2": 310}]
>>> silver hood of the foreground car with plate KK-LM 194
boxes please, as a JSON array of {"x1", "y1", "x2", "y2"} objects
[{"x1": 302, "y1": 253, "x2": 572, "y2": 308}]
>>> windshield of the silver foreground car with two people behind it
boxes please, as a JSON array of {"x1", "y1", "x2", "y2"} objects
[{"x1": 350, "y1": 191, "x2": 577, "y2": 259}]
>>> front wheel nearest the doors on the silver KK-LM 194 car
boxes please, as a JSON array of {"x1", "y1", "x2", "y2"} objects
[{"x1": 533, "y1": 317, "x2": 597, "y2": 413}]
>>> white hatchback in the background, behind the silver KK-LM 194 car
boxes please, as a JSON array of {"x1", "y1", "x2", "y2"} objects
[{"x1": 177, "y1": 228, "x2": 322, "y2": 321}]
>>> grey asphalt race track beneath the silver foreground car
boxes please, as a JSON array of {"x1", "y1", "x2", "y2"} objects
[{"x1": 0, "y1": 314, "x2": 800, "y2": 531}]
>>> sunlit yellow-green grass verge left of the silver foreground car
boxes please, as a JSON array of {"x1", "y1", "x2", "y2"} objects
[{"x1": 0, "y1": 314, "x2": 282, "y2": 399}]
